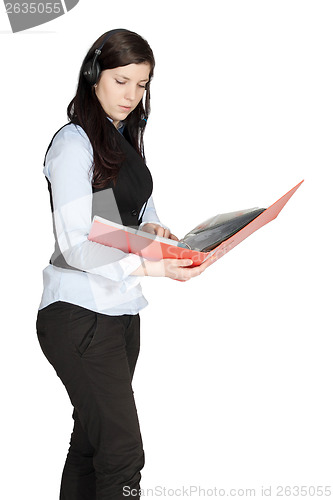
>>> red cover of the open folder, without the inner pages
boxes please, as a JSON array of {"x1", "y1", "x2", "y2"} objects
[{"x1": 88, "y1": 181, "x2": 303, "y2": 266}]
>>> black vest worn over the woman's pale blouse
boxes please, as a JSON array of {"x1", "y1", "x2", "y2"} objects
[{"x1": 44, "y1": 123, "x2": 153, "y2": 269}]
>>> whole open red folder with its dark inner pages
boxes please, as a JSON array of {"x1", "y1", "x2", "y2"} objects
[{"x1": 88, "y1": 181, "x2": 303, "y2": 266}]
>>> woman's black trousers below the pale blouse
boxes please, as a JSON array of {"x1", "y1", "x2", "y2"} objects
[{"x1": 37, "y1": 302, "x2": 144, "y2": 500}]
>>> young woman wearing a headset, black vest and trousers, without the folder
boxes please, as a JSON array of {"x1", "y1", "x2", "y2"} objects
[{"x1": 37, "y1": 29, "x2": 214, "y2": 500}]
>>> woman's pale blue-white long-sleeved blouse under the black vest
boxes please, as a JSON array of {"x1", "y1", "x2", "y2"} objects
[{"x1": 39, "y1": 124, "x2": 167, "y2": 316}]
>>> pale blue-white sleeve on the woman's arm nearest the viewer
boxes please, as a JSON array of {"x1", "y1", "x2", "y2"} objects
[{"x1": 44, "y1": 124, "x2": 144, "y2": 285}]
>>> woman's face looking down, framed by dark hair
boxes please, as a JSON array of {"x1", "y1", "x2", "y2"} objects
[{"x1": 95, "y1": 63, "x2": 150, "y2": 127}]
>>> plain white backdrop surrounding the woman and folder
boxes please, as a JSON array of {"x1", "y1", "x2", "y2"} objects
[{"x1": 0, "y1": 0, "x2": 333, "y2": 500}]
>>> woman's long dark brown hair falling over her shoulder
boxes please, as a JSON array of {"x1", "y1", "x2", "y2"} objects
[{"x1": 67, "y1": 30, "x2": 155, "y2": 188}]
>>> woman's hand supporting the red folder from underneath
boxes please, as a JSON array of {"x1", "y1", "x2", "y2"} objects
[{"x1": 132, "y1": 255, "x2": 217, "y2": 281}]
